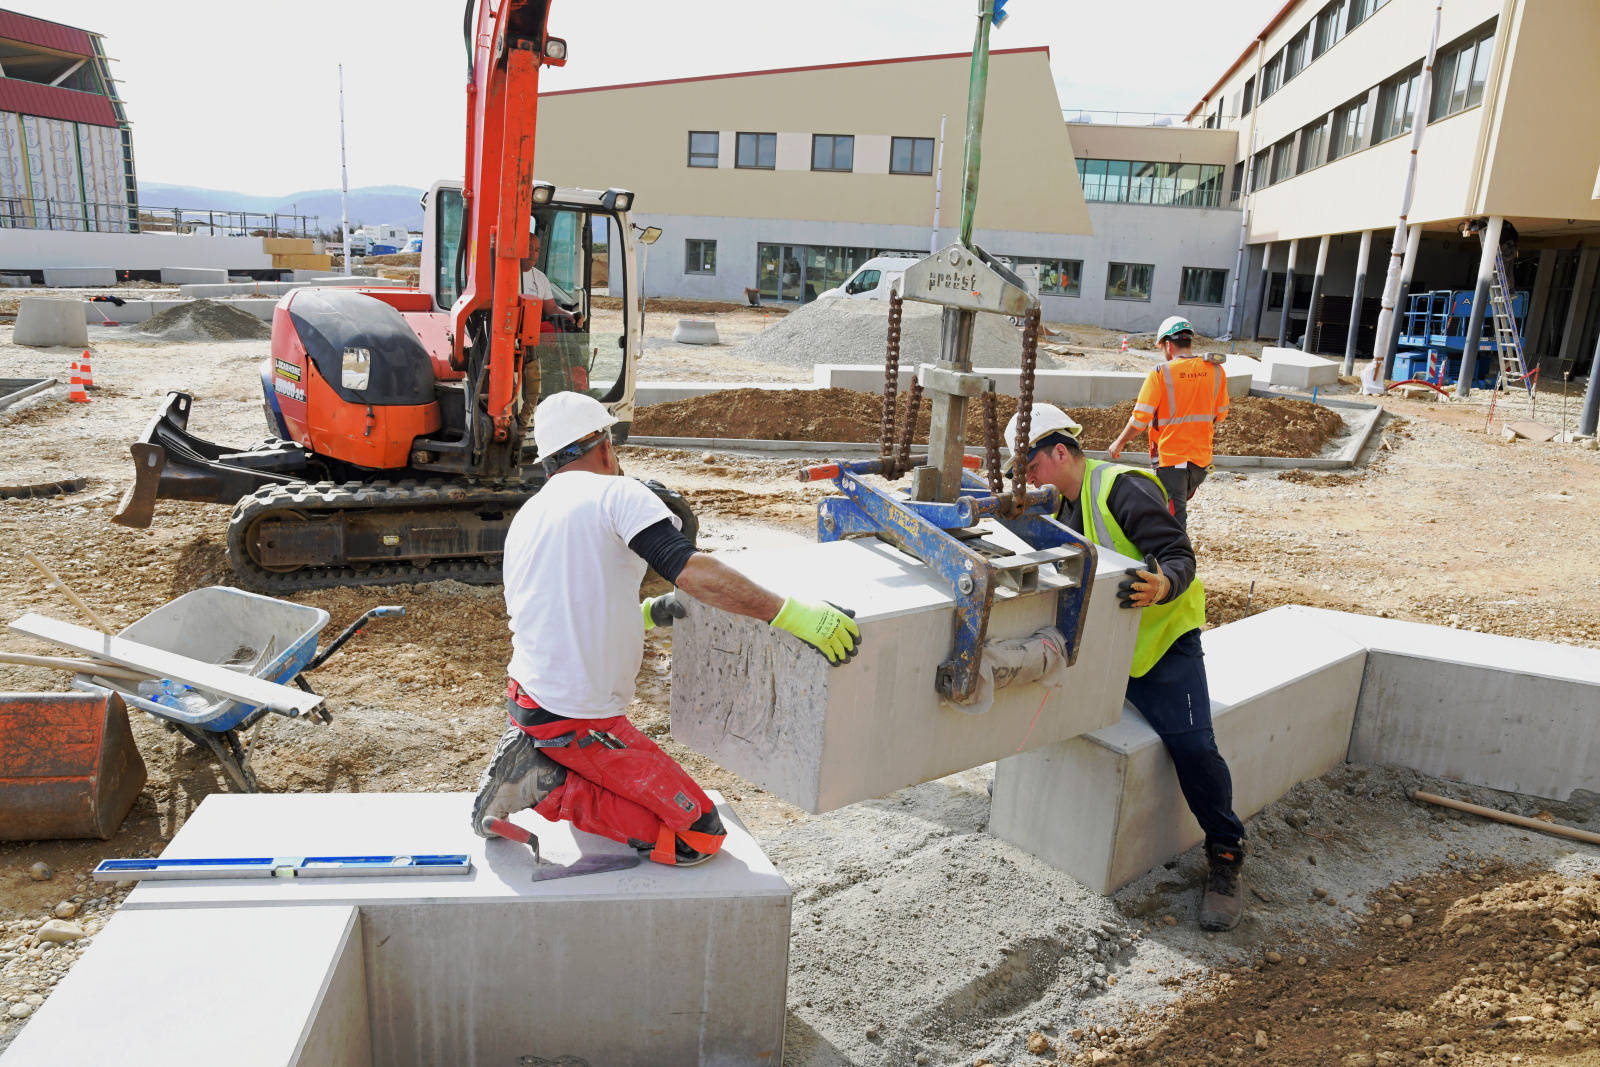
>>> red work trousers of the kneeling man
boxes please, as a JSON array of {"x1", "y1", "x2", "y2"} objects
[{"x1": 510, "y1": 703, "x2": 723, "y2": 864}]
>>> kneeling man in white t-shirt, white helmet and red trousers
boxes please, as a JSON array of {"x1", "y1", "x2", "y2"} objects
[{"x1": 472, "y1": 392, "x2": 861, "y2": 865}]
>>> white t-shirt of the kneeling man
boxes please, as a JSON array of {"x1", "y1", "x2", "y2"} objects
[{"x1": 504, "y1": 470, "x2": 682, "y2": 718}]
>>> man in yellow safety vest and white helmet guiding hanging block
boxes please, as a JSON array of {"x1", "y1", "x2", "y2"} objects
[{"x1": 1005, "y1": 403, "x2": 1245, "y2": 929}]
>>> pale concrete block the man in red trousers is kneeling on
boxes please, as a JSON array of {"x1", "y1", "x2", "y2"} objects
[{"x1": 121, "y1": 793, "x2": 790, "y2": 1067}]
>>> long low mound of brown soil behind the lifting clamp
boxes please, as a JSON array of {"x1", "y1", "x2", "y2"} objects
[{"x1": 632, "y1": 389, "x2": 1344, "y2": 456}]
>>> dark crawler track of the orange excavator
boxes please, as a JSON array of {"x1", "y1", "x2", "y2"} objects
[{"x1": 227, "y1": 478, "x2": 698, "y2": 595}]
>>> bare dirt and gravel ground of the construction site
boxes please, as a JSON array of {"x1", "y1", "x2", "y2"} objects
[{"x1": 0, "y1": 310, "x2": 1600, "y2": 1067}]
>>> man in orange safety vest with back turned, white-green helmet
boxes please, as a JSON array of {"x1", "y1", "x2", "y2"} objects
[{"x1": 1110, "y1": 315, "x2": 1227, "y2": 530}]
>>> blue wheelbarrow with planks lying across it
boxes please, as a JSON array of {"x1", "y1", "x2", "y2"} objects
[{"x1": 72, "y1": 585, "x2": 405, "y2": 793}]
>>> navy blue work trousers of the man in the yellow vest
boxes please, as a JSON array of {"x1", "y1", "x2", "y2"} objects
[{"x1": 1128, "y1": 630, "x2": 1245, "y2": 848}]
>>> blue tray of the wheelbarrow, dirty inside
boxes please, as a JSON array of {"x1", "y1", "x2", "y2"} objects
[{"x1": 72, "y1": 585, "x2": 328, "y2": 733}]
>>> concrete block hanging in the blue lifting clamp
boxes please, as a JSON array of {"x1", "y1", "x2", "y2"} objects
[{"x1": 672, "y1": 531, "x2": 1138, "y2": 813}]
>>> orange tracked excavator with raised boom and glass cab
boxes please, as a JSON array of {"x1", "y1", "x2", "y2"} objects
[{"x1": 114, "y1": 0, "x2": 696, "y2": 593}]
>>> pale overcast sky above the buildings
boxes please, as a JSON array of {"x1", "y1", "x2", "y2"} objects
[{"x1": 31, "y1": 0, "x2": 1282, "y2": 195}]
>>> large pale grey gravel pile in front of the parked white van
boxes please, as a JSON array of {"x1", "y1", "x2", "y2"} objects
[{"x1": 733, "y1": 298, "x2": 1024, "y2": 366}]
